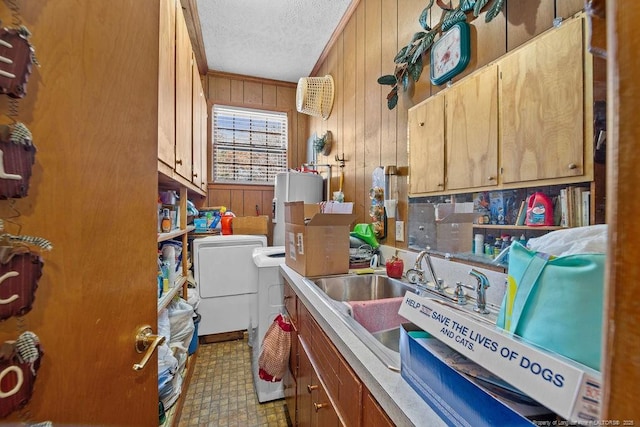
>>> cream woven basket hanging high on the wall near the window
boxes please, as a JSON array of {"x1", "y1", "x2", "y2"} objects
[{"x1": 296, "y1": 74, "x2": 334, "y2": 120}]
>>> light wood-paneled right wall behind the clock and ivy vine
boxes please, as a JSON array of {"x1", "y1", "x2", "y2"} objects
[{"x1": 308, "y1": 0, "x2": 584, "y2": 247}]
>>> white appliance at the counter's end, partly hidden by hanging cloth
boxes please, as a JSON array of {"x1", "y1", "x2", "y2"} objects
[{"x1": 251, "y1": 246, "x2": 285, "y2": 403}]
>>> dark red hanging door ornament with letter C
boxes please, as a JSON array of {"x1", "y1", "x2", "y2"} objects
[{"x1": 0, "y1": 245, "x2": 44, "y2": 320}]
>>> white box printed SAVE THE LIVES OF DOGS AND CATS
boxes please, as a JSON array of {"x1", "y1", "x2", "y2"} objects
[{"x1": 398, "y1": 292, "x2": 602, "y2": 425}]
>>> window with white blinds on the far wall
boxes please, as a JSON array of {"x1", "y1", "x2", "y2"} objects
[{"x1": 211, "y1": 105, "x2": 288, "y2": 184}]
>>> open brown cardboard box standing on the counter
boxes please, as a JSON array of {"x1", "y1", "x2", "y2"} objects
[{"x1": 284, "y1": 202, "x2": 356, "y2": 277}]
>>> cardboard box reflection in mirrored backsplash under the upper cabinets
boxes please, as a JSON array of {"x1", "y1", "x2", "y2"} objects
[{"x1": 436, "y1": 213, "x2": 479, "y2": 253}]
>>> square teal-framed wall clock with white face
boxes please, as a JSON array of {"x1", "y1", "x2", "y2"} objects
[{"x1": 431, "y1": 21, "x2": 471, "y2": 85}]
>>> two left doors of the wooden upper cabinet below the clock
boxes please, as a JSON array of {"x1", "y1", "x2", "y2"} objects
[{"x1": 408, "y1": 65, "x2": 498, "y2": 195}]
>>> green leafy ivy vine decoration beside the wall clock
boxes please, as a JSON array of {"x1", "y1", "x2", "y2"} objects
[{"x1": 378, "y1": 0, "x2": 505, "y2": 110}]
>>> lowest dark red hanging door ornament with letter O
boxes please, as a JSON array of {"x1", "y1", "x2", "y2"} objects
[{"x1": 0, "y1": 331, "x2": 44, "y2": 418}]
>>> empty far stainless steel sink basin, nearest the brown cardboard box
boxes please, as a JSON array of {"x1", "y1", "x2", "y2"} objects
[{"x1": 313, "y1": 274, "x2": 416, "y2": 301}]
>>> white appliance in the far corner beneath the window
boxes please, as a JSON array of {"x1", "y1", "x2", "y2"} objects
[{"x1": 193, "y1": 235, "x2": 267, "y2": 343}]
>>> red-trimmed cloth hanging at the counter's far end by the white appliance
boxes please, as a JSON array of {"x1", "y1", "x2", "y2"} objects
[{"x1": 258, "y1": 314, "x2": 291, "y2": 382}]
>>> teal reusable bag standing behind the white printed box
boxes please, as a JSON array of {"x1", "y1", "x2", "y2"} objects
[{"x1": 496, "y1": 242, "x2": 605, "y2": 371}]
